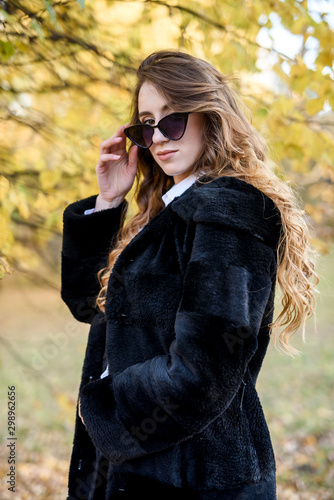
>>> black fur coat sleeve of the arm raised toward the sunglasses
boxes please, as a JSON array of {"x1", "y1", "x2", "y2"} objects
[{"x1": 61, "y1": 195, "x2": 128, "y2": 323}]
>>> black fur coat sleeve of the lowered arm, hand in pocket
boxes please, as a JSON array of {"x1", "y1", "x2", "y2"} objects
[{"x1": 80, "y1": 191, "x2": 275, "y2": 463}]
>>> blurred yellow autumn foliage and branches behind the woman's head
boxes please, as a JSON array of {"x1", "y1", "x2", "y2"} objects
[{"x1": 0, "y1": 0, "x2": 334, "y2": 279}]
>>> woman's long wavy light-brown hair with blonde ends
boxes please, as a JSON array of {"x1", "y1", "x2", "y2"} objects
[{"x1": 97, "y1": 50, "x2": 319, "y2": 355}]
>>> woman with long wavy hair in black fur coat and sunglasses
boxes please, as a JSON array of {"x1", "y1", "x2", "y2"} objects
[{"x1": 62, "y1": 51, "x2": 317, "y2": 500}]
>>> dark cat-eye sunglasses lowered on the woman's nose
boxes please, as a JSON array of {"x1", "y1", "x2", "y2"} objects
[{"x1": 124, "y1": 113, "x2": 190, "y2": 148}]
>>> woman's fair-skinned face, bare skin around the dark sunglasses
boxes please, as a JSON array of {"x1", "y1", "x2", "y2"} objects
[{"x1": 138, "y1": 82, "x2": 205, "y2": 184}]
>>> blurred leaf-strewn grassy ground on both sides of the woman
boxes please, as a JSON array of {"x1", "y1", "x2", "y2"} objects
[{"x1": 0, "y1": 248, "x2": 334, "y2": 500}]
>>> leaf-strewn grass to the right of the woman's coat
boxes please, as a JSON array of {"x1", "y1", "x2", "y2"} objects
[{"x1": 257, "y1": 244, "x2": 334, "y2": 500}]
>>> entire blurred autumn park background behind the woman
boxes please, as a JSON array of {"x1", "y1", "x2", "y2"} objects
[{"x1": 0, "y1": 0, "x2": 334, "y2": 500}]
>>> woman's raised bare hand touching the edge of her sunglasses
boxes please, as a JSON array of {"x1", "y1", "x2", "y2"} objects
[{"x1": 95, "y1": 124, "x2": 138, "y2": 210}]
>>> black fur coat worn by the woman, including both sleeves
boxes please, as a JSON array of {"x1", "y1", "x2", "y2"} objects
[{"x1": 62, "y1": 177, "x2": 281, "y2": 500}]
